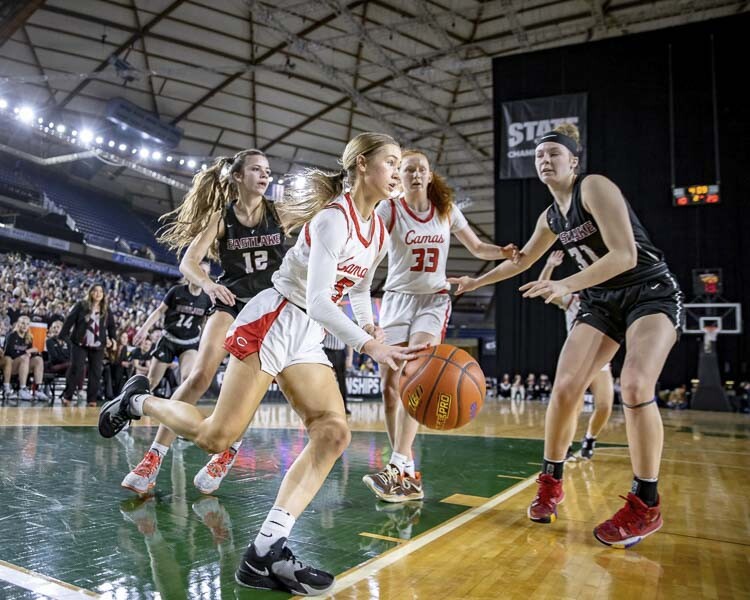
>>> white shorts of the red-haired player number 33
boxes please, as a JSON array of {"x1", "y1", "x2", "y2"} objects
[{"x1": 380, "y1": 292, "x2": 451, "y2": 344}]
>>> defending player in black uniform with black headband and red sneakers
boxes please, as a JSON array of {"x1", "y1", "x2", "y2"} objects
[{"x1": 449, "y1": 124, "x2": 682, "y2": 548}]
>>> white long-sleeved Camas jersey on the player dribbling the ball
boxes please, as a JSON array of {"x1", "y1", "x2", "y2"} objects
[{"x1": 271, "y1": 194, "x2": 388, "y2": 352}]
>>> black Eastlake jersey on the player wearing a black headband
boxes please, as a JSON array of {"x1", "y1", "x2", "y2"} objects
[{"x1": 547, "y1": 175, "x2": 669, "y2": 289}]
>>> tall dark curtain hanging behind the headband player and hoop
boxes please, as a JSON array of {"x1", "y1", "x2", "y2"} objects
[{"x1": 493, "y1": 14, "x2": 750, "y2": 385}]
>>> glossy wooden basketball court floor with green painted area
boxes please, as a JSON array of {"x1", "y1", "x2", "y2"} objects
[{"x1": 0, "y1": 400, "x2": 750, "y2": 600}]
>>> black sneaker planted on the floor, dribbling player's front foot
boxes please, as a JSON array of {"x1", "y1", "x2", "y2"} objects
[{"x1": 234, "y1": 538, "x2": 335, "y2": 596}]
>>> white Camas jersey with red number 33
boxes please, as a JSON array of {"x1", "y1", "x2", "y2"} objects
[{"x1": 376, "y1": 196, "x2": 468, "y2": 294}]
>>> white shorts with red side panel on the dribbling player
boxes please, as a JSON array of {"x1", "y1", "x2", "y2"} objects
[{"x1": 224, "y1": 288, "x2": 332, "y2": 377}]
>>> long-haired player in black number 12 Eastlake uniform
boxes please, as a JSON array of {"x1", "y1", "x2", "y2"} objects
[{"x1": 122, "y1": 150, "x2": 285, "y2": 494}]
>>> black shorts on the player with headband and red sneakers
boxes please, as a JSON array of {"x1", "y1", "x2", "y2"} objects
[{"x1": 576, "y1": 273, "x2": 685, "y2": 344}]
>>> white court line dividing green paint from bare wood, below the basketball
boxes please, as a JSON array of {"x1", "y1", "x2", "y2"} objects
[{"x1": 329, "y1": 473, "x2": 538, "y2": 597}]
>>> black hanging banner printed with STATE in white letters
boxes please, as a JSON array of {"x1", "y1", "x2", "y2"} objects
[{"x1": 500, "y1": 94, "x2": 586, "y2": 179}]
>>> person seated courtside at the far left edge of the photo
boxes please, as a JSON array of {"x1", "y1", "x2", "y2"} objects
[{"x1": 3, "y1": 316, "x2": 49, "y2": 400}]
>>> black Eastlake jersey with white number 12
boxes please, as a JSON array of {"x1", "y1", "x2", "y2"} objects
[{"x1": 217, "y1": 199, "x2": 286, "y2": 302}]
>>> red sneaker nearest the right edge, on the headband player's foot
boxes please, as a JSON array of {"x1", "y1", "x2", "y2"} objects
[{"x1": 594, "y1": 492, "x2": 664, "y2": 548}]
